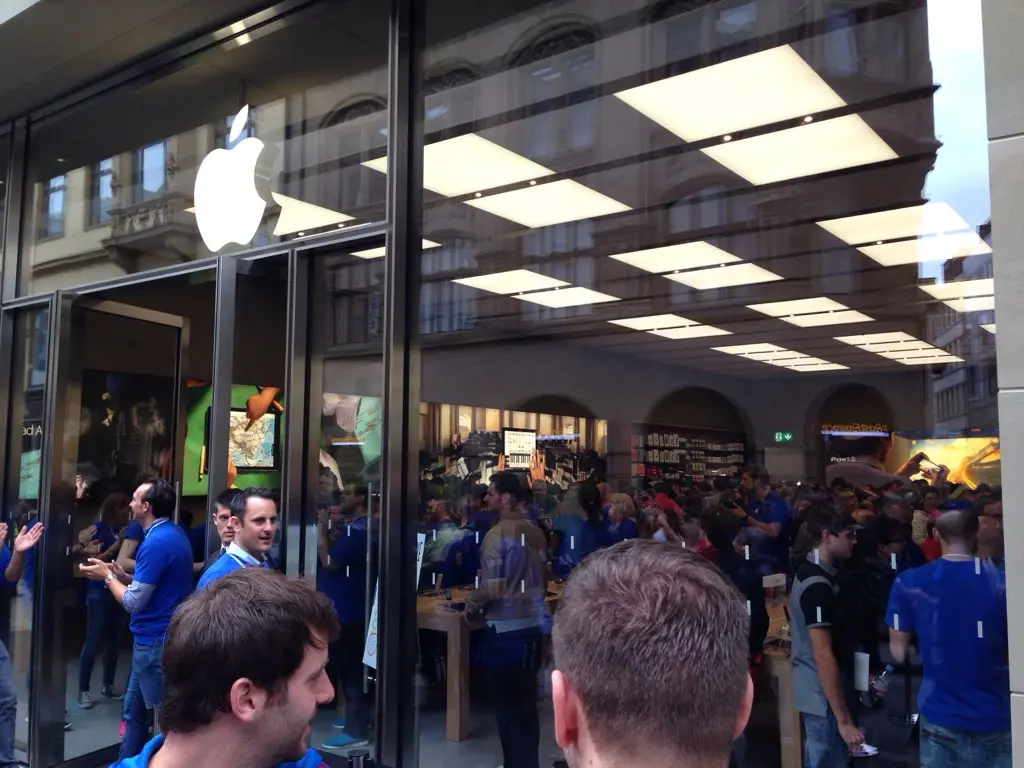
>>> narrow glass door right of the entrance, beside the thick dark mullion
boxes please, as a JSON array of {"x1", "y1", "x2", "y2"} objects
[{"x1": 285, "y1": 233, "x2": 384, "y2": 765}]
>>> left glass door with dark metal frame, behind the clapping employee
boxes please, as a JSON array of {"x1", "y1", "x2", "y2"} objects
[{"x1": 29, "y1": 292, "x2": 189, "y2": 766}]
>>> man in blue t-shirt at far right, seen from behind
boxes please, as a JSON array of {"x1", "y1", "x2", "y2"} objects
[{"x1": 886, "y1": 510, "x2": 1011, "y2": 768}]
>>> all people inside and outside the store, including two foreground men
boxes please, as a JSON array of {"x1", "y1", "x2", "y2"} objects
[{"x1": 0, "y1": 438, "x2": 1010, "y2": 768}]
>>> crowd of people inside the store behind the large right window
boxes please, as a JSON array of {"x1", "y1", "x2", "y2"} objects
[{"x1": 421, "y1": 444, "x2": 1010, "y2": 768}]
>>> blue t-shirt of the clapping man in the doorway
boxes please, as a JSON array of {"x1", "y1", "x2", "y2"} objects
[{"x1": 129, "y1": 518, "x2": 193, "y2": 645}]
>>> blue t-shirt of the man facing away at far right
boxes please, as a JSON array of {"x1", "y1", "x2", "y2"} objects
[{"x1": 886, "y1": 559, "x2": 1010, "y2": 731}]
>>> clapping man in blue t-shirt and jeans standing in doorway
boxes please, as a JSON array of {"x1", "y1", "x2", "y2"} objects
[{"x1": 82, "y1": 478, "x2": 193, "y2": 760}]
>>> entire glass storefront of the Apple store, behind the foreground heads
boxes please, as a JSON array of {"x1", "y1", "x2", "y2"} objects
[{"x1": 0, "y1": 0, "x2": 1024, "y2": 768}]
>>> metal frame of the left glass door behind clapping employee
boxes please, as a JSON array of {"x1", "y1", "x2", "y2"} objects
[{"x1": 29, "y1": 291, "x2": 189, "y2": 768}]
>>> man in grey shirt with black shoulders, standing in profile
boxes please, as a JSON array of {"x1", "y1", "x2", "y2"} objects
[{"x1": 790, "y1": 500, "x2": 864, "y2": 768}]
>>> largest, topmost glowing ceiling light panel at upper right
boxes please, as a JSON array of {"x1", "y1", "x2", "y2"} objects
[{"x1": 615, "y1": 45, "x2": 846, "y2": 141}]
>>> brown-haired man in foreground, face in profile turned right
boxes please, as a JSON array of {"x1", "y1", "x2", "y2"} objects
[{"x1": 112, "y1": 568, "x2": 338, "y2": 768}]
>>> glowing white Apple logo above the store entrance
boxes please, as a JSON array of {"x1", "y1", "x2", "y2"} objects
[{"x1": 194, "y1": 104, "x2": 271, "y2": 253}]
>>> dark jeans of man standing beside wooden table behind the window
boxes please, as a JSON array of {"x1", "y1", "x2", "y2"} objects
[{"x1": 481, "y1": 629, "x2": 542, "y2": 768}]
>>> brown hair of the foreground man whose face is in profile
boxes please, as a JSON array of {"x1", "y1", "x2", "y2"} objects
[{"x1": 160, "y1": 568, "x2": 339, "y2": 733}]
